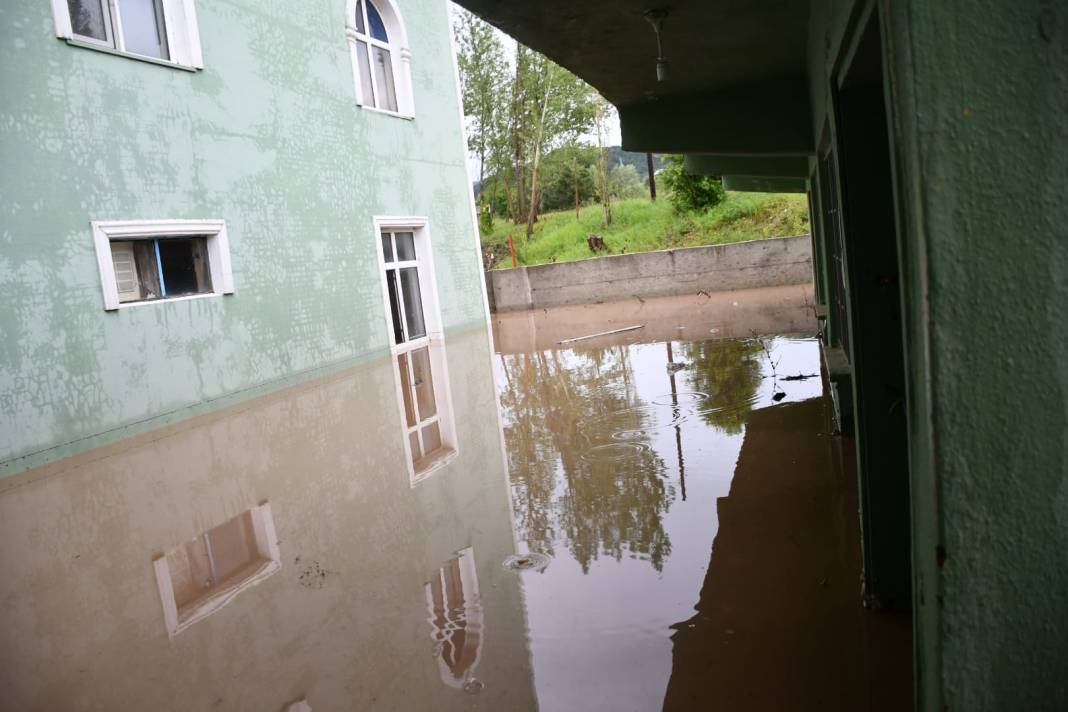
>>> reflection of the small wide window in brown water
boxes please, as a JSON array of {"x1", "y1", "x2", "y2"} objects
[{"x1": 155, "y1": 503, "x2": 282, "y2": 636}]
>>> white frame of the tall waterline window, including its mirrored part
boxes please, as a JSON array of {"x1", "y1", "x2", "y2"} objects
[{"x1": 373, "y1": 217, "x2": 459, "y2": 487}]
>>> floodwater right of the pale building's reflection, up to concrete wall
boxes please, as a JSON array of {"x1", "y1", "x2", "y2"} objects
[{"x1": 496, "y1": 290, "x2": 911, "y2": 711}]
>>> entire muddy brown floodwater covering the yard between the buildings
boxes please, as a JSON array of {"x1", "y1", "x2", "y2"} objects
[{"x1": 0, "y1": 288, "x2": 910, "y2": 712}]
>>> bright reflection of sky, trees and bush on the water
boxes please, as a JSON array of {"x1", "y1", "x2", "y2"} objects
[{"x1": 498, "y1": 313, "x2": 821, "y2": 711}]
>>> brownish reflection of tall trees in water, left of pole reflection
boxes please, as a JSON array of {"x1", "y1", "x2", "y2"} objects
[{"x1": 500, "y1": 347, "x2": 675, "y2": 572}]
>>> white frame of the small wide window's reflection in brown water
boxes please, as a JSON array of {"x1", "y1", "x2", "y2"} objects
[{"x1": 153, "y1": 502, "x2": 282, "y2": 637}]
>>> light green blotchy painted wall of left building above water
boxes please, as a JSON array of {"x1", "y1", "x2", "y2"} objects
[{"x1": 0, "y1": 0, "x2": 485, "y2": 475}]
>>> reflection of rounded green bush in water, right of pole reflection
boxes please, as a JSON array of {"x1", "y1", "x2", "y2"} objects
[{"x1": 681, "y1": 338, "x2": 764, "y2": 434}]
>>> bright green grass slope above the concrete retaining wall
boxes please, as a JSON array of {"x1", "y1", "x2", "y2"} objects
[{"x1": 482, "y1": 192, "x2": 808, "y2": 268}]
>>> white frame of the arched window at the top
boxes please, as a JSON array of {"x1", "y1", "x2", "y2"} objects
[{"x1": 345, "y1": 0, "x2": 415, "y2": 118}]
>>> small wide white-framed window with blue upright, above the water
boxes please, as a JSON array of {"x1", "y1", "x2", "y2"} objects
[{"x1": 93, "y1": 220, "x2": 234, "y2": 310}]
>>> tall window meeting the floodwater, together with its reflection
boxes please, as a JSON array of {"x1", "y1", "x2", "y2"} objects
[{"x1": 376, "y1": 220, "x2": 456, "y2": 482}]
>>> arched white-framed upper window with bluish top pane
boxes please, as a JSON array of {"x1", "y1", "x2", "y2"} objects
[{"x1": 346, "y1": 0, "x2": 414, "y2": 117}]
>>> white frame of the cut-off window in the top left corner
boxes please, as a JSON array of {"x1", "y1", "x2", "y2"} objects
[{"x1": 51, "y1": 0, "x2": 204, "y2": 69}]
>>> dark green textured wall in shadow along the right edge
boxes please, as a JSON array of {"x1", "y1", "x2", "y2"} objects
[{"x1": 810, "y1": 0, "x2": 1068, "y2": 711}]
